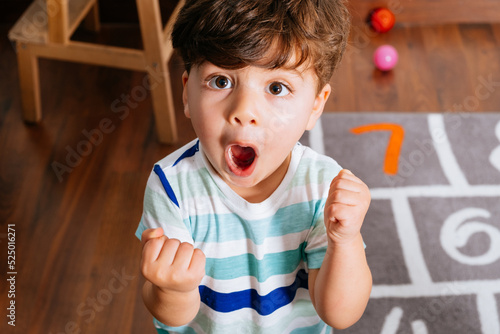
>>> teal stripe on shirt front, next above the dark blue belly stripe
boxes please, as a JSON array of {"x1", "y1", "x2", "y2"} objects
[{"x1": 205, "y1": 242, "x2": 306, "y2": 282}]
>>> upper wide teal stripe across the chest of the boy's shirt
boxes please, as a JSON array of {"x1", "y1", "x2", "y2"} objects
[{"x1": 190, "y1": 200, "x2": 321, "y2": 245}]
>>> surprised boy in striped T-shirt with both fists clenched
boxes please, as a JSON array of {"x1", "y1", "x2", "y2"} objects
[{"x1": 136, "y1": 0, "x2": 371, "y2": 334}]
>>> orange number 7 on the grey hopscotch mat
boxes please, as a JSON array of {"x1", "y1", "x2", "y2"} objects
[{"x1": 351, "y1": 123, "x2": 405, "y2": 175}]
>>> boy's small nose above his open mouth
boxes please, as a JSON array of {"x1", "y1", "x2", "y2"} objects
[{"x1": 229, "y1": 88, "x2": 258, "y2": 126}]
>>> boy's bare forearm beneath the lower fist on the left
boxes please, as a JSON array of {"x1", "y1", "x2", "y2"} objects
[{"x1": 142, "y1": 281, "x2": 200, "y2": 327}]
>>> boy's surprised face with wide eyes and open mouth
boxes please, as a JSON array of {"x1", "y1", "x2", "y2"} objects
[{"x1": 183, "y1": 62, "x2": 330, "y2": 201}]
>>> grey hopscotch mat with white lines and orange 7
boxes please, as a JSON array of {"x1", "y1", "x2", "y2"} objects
[{"x1": 301, "y1": 112, "x2": 500, "y2": 334}]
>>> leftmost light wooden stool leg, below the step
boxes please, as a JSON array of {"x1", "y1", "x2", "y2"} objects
[{"x1": 16, "y1": 43, "x2": 42, "y2": 123}]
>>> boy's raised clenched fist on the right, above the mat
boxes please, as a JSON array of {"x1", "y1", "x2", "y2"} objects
[{"x1": 325, "y1": 169, "x2": 371, "y2": 244}]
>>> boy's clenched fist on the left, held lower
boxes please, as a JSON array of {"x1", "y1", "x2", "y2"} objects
[{"x1": 141, "y1": 228, "x2": 205, "y2": 292}]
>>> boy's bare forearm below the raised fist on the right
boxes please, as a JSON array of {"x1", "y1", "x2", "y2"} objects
[{"x1": 312, "y1": 235, "x2": 372, "y2": 328}]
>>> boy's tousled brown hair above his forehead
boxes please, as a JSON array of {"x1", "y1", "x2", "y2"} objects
[{"x1": 172, "y1": 0, "x2": 350, "y2": 91}]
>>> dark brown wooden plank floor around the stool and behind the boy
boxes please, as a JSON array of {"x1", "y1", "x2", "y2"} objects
[{"x1": 0, "y1": 24, "x2": 500, "y2": 334}]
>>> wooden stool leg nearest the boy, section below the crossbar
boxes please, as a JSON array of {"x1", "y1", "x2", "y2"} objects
[{"x1": 148, "y1": 63, "x2": 177, "y2": 144}]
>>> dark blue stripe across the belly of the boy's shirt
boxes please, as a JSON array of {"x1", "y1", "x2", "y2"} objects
[{"x1": 199, "y1": 269, "x2": 308, "y2": 316}]
